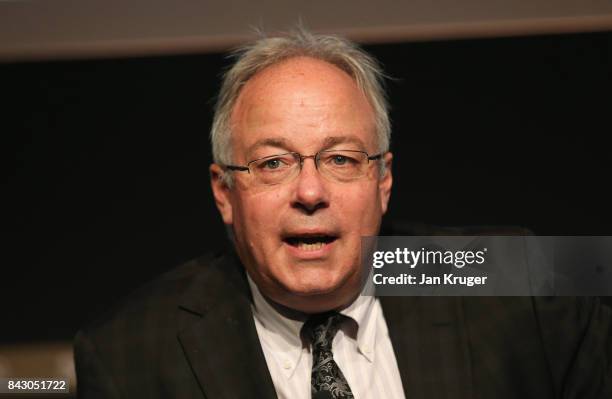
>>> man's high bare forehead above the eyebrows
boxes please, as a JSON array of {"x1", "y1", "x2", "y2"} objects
[{"x1": 231, "y1": 57, "x2": 376, "y2": 156}]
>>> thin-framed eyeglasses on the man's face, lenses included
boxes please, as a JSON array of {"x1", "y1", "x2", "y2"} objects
[{"x1": 222, "y1": 150, "x2": 383, "y2": 185}]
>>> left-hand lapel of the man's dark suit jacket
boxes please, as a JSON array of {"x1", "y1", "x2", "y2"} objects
[{"x1": 179, "y1": 257, "x2": 276, "y2": 399}]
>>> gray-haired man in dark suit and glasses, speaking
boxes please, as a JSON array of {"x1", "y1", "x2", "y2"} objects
[{"x1": 75, "y1": 31, "x2": 612, "y2": 399}]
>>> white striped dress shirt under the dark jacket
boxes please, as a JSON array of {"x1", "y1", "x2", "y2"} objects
[{"x1": 248, "y1": 277, "x2": 405, "y2": 399}]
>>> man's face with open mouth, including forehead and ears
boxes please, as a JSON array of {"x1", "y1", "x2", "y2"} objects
[{"x1": 211, "y1": 57, "x2": 391, "y2": 313}]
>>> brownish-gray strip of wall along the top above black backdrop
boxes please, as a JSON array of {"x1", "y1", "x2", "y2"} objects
[{"x1": 0, "y1": 0, "x2": 612, "y2": 62}]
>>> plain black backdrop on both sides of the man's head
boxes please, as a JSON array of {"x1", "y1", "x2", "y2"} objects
[{"x1": 0, "y1": 32, "x2": 612, "y2": 343}]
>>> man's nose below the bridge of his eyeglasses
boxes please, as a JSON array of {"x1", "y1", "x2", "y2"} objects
[{"x1": 291, "y1": 157, "x2": 329, "y2": 215}]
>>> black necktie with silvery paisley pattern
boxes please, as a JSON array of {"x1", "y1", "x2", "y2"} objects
[{"x1": 304, "y1": 312, "x2": 354, "y2": 399}]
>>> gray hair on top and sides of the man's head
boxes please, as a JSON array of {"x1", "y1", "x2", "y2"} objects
[{"x1": 210, "y1": 27, "x2": 391, "y2": 184}]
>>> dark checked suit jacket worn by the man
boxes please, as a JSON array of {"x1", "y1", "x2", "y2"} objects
[{"x1": 75, "y1": 252, "x2": 612, "y2": 399}]
